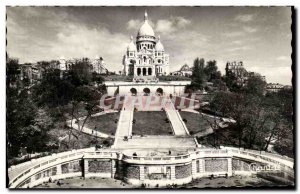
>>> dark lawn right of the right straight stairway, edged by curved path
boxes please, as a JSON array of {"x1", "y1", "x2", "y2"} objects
[{"x1": 179, "y1": 111, "x2": 214, "y2": 135}]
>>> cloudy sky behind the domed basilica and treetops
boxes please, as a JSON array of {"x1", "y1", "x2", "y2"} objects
[{"x1": 6, "y1": 6, "x2": 292, "y2": 85}]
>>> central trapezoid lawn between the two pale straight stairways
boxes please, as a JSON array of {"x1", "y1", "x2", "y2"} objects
[{"x1": 132, "y1": 111, "x2": 173, "y2": 135}]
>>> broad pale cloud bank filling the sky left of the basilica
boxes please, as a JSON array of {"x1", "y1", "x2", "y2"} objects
[{"x1": 7, "y1": 10, "x2": 129, "y2": 71}]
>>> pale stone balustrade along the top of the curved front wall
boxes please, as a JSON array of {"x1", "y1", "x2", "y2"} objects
[{"x1": 8, "y1": 147, "x2": 294, "y2": 188}]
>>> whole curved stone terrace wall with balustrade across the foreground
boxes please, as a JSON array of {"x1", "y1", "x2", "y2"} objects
[{"x1": 8, "y1": 147, "x2": 294, "y2": 188}]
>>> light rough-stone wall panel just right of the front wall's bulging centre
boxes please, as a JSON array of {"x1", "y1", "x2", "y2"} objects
[{"x1": 205, "y1": 158, "x2": 228, "y2": 172}]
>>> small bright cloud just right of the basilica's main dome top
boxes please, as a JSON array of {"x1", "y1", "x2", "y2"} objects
[{"x1": 155, "y1": 17, "x2": 191, "y2": 34}]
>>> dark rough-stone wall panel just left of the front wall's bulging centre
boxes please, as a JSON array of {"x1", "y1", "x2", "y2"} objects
[{"x1": 88, "y1": 159, "x2": 111, "y2": 173}]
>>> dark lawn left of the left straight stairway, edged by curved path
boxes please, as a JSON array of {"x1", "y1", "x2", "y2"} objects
[{"x1": 85, "y1": 112, "x2": 120, "y2": 135}]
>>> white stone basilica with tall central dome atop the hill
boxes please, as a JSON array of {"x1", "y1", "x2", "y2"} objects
[{"x1": 123, "y1": 12, "x2": 169, "y2": 77}]
